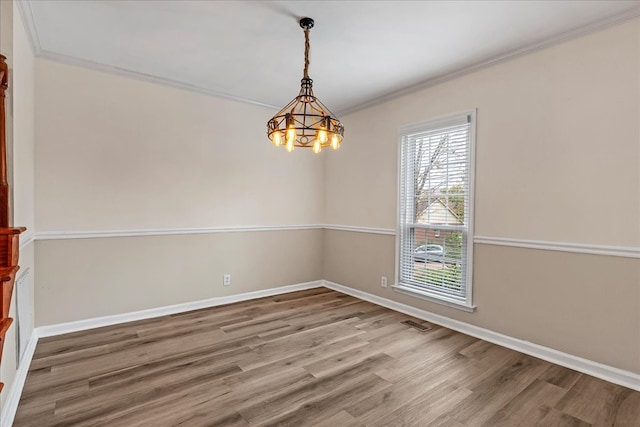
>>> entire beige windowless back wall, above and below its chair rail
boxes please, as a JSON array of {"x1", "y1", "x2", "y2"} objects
[{"x1": 35, "y1": 59, "x2": 323, "y2": 325}]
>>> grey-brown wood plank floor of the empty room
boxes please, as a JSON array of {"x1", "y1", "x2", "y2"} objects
[{"x1": 14, "y1": 288, "x2": 640, "y2": 427}]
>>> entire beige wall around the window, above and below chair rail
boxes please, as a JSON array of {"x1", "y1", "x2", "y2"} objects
[{"x1": 323, "y1": 19, "x2": 640, "y2": 372}]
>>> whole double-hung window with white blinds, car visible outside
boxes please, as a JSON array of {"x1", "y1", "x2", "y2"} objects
[{"x1": 394, "y1": 112, "x2": 475, "y2": 311}]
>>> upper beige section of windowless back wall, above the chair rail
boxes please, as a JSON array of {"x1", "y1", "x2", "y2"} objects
[{"x1": 36, "y1": 59, "x2": 323, "y2": 233}]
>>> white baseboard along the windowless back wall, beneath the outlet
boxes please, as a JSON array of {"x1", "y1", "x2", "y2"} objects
[{"x1": 36, "y1": 280, "x2": 322, "y2": 337}]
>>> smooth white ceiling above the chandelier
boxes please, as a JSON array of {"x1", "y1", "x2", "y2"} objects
[{"x1": 18, "y1": 0, "x2": 640, "y2": 113}]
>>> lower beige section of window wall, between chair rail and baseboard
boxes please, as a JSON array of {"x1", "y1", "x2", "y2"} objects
[{"x1": 322, "y1": 230, "x2": 640, "y2": 372}]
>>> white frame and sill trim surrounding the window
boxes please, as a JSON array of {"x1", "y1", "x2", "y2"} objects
[{"x1": 392, "y1": 109, "x2": 477, "y2": 312}]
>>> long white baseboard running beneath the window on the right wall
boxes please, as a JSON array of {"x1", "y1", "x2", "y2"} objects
[{"x1": 323, "y1": 280, "x2": 640, "y2": 391}]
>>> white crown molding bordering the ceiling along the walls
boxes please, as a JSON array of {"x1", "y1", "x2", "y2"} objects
[{"x1": 16, "y1": 0, "x2": 640, "y2": 116}]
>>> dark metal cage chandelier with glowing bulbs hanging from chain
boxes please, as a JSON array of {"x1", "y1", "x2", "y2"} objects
[{"x1": 267, "y1": 18, "x2": 344, "y2": 154}]
